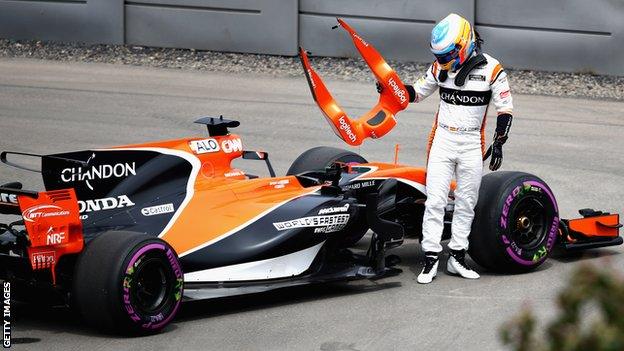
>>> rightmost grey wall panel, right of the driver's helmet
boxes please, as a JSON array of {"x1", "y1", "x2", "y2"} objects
[{"x1": 475, "y1": 0, "x2": 624, "y2": 75}]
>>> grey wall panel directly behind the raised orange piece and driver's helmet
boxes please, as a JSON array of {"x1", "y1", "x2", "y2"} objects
[{"x1": 299, "y1": 0, "x2": 474, "y2": 62}]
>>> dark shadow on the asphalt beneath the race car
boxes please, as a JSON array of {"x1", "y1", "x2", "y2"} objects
[{"x1": 13, "y1": 242, "x2": 620, "y2": 340}]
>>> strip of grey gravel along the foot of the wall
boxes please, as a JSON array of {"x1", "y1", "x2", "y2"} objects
[{"x1": 0, "y1": 39, "x2": 624, "y2": 100}]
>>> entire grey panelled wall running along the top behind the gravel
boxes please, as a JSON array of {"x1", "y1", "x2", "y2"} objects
[{"x1": 0, "y1": 0, "x2": 624, "y2": 75}]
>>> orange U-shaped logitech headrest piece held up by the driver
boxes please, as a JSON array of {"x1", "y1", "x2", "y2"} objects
[{"x1": 299, "y1": 18, "x2": 409, "y2": 146}]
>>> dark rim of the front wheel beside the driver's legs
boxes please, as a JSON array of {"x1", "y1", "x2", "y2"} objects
[{"x1": 510, "y1": 196, "x2": 549, "y2": 250}]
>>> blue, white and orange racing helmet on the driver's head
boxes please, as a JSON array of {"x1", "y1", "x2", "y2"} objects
[{"x1": 430, "y1": 13, "x2": 476, "y2": 71}]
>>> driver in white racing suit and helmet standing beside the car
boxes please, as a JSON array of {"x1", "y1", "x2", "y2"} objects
[{"x1": 378, "y1": 13, "x2": 513, "y2": 284}]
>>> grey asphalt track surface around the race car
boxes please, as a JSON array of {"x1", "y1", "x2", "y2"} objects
[{"x1": 0, "y1": 59, "x2": 624, "y2": 351}]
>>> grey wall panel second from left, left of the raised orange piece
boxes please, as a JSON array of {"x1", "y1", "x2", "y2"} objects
[{"x1": 125, "y1": 0, "x2": 297, "y2": 55}]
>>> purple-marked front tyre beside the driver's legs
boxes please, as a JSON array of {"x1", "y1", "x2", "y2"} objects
[{"x1": 469, "y1": 172, "x2": 559, "y2": 273}]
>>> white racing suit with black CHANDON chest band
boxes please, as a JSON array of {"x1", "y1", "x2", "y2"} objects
[{"x1": 414, "y1": 54, "x2": 513, "y2": 253}]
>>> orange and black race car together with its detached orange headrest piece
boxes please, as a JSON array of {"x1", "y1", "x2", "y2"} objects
[{"x1": 0, "y1": 18, "x2": 622, "y2": 334}]
